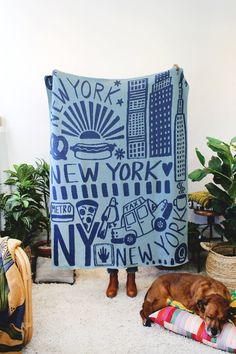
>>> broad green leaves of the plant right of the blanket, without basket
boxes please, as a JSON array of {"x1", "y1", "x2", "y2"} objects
[{"x1": 189, "y1": 137, "x2": 236, "y2": 245}]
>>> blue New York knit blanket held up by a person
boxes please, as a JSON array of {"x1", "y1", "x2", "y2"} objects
[{"x1": 45, "y1": 68, "x2": 188, "y2": 268}]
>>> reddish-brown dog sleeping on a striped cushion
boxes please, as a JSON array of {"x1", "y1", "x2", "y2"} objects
[{"x1": 140, "y1": 273, "x2": 230, "y2": 337}]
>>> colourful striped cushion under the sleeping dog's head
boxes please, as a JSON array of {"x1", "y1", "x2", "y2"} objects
[{"x1": 149, "y1": 292, "x2": 236, "y2": 353}]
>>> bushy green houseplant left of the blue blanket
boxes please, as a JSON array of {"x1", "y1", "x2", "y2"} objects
[{"x1": 0, "y1": 160, "x2": 50, "y2": 247}]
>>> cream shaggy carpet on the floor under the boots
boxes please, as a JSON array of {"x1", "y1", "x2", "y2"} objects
[{"x1": 23, "y1": 265, "x2": 222, "y2": 354}]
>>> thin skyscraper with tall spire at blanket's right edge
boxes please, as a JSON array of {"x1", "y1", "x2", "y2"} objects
[{"x1": 174, "y1": 81, "x2": 187, "y2": 182}]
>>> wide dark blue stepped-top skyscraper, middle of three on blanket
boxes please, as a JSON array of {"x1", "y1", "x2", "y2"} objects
[{"x1": 149, "y1": 71, "x2": 173, "y2": 157}]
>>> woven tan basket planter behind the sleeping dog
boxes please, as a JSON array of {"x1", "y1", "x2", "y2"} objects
[{"x1": 201, "y1": 242, "x2": 236, "y2": 289}]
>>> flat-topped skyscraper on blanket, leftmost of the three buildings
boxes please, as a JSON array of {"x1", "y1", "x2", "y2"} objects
[{"x1": 127, "y1": 79, "x2": 148, "y2": 159}]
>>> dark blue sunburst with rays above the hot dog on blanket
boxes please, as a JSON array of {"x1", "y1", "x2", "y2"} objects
[{"x1": 61, "y1": 101, "x2": 124, "y2": 140}]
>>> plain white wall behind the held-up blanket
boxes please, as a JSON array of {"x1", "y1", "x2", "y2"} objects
[{"x1": 0, "y1": 0, "x2": 236, "y2": 190}]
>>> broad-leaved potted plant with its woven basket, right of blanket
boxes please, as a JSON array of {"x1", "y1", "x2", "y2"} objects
[{"x1": 189, "y1": 137, "x2": 236, "y2": 287}]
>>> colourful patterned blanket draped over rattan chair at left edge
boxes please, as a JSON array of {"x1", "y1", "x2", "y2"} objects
[{"x1": 0, "y1": 237, "x2": 25, "y2": 353}]
